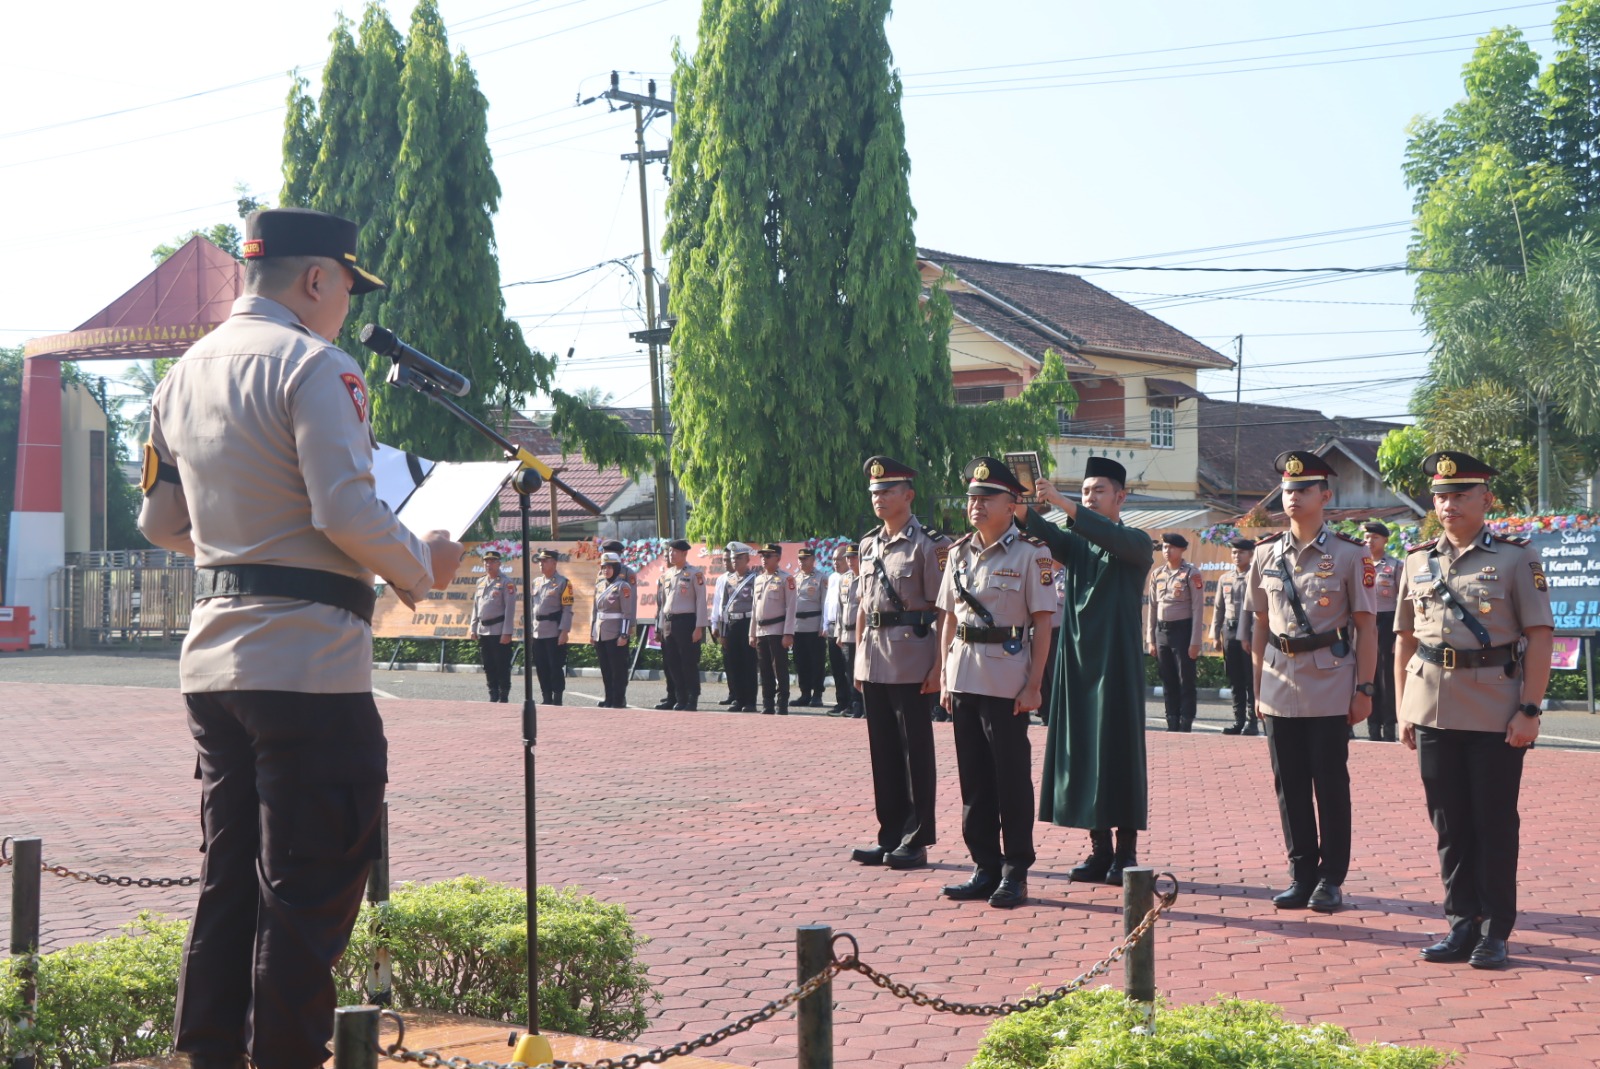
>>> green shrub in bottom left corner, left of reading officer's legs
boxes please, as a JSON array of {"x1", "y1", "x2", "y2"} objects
[{"x1": 0, "y1": 912, "x2": 189, "y2": 1069}]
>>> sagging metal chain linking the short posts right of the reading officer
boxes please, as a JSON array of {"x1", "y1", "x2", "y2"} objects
[{"x1": 378, "y1": 872, "x2": 1178, "y2": 1069}]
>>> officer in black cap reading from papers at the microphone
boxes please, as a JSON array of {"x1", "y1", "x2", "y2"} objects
[{"x1": 139, "y1": 208, "x2": 461, "y2": 1069}]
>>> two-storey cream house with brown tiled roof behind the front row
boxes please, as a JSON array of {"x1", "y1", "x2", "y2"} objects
[{"x1": 918, "y1": 250, "x2": 1234, "y2": 502}]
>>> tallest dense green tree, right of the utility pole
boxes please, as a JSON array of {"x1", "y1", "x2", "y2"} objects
[{"x1": 664, "y1": 0, "x2": 1074, "y2": 541}]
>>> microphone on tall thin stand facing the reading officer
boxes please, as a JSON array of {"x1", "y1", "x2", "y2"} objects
[{"x1": 389, "y1": 363, "x2": 556, "y2": 1066}]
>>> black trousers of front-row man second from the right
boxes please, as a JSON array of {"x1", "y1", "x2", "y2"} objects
[{"x1": 1262, "y1": 715, "x2": 1350, "y2": 883}]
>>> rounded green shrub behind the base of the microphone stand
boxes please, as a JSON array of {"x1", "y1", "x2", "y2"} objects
[{"x1": 336, "y1": 877, "x2": 659, "y2": 1040}]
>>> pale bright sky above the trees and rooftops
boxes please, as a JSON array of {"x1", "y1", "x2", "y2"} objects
[{"x1": 0, "y1": 0, "x2": 1557, "y2": 419}]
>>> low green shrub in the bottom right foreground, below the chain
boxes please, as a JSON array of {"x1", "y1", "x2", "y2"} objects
[{"x1": 968, "y1": 987, "x2": 1454, "y2": 1069}]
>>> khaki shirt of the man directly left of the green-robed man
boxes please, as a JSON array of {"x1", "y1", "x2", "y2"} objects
[{"x1": 939, "y1": 528, "x2": 1061, "y2": 698}]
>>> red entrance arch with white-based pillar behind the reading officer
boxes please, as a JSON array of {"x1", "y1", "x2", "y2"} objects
[{"x1": 5, "y1": 235, "x2": 243, "y2": 645}]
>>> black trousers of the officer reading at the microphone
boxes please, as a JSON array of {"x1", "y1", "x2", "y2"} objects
[{"x1": 176, "y1": 691, "x2": 387, "y2": 1069}]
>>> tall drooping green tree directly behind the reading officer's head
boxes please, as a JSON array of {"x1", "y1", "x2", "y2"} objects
[{"x1": 282, "y1": 0, "x2": 658, "y2": 470}]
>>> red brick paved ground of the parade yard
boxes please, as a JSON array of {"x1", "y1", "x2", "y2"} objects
[{"x1": 0, "y1": 683, "x2": 1600, "y2": 1069}]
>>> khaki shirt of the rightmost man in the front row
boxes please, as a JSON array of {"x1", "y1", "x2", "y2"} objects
[{"x1": 1395, "y1": 530, "x2": 1555, "y2": 733}]
